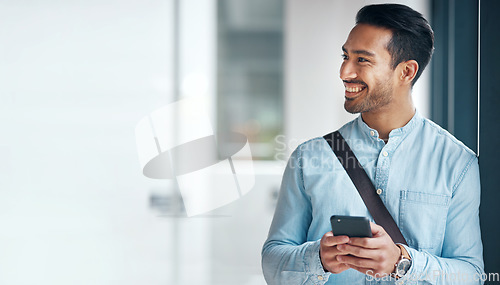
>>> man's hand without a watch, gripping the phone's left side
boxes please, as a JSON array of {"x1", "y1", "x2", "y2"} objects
[{"x1": 319, "y1": 232, "x2": 350, "y2": 274}]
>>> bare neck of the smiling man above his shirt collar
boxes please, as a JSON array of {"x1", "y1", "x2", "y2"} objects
[{"x1": 361, "y1": 91, "x2": 415, "y2": 140}]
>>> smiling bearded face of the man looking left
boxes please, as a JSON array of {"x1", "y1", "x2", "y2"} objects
[{"x1": 340, "y1": 24, "x2": 395, "y2": 114}]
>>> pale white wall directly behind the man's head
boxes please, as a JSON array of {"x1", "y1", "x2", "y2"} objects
[{"x1": 285, "y1": 0, "x2": 430, "y2": 149}]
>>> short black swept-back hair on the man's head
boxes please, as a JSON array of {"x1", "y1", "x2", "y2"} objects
[{"x1": 356, "y1": 4, "x2": 434, "y2": 85}]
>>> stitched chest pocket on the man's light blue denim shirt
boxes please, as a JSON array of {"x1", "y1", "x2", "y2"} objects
[{"x1": 399, "y1": 190, "x2": 451, "y2": 251}]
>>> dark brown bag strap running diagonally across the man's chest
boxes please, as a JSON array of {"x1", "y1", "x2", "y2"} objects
[{"x1": 323, "y1": 131, "x2": 407, "y2": 245}]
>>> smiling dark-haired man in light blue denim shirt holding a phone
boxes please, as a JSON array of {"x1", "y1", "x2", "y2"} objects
[{"x1": 262, "y1": 4, "x2": 484, "y2": 284}]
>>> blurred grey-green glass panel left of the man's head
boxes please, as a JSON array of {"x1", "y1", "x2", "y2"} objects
[{"x1": 217, "y1": 0, "x2": 283, "y2": 159}]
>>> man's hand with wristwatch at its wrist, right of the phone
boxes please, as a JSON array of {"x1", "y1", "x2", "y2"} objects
[{"x1": 337, "y1": 223, "x2": 401, "y2": 277}]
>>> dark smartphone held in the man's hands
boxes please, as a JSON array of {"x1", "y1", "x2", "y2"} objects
[{"x1": 330, "y1": 215, "x2": 372, "y2": 237}]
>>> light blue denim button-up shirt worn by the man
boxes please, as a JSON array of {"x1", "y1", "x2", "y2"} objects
[{"x1": 262, "y1": 111, "x2": 484, "y2": 284}]
